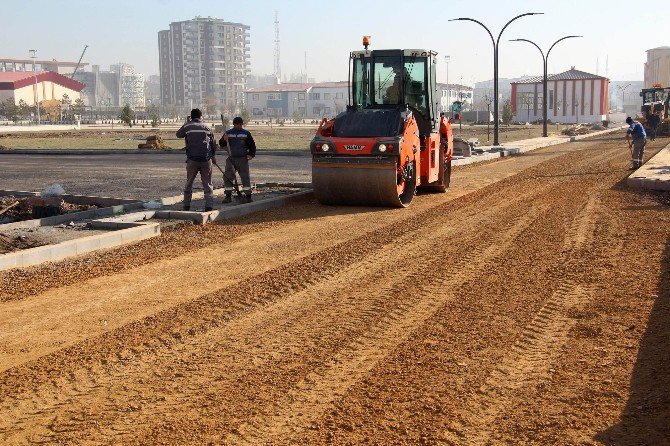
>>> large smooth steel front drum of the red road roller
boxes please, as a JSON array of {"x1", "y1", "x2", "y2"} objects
[{"x1": 312, "y1": 157, "x2": 416, "y2": 207}]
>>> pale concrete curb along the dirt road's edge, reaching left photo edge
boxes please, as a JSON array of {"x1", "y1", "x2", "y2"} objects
[{"x1": 0, "y1": 223, "x2": 161, "y2": 271}]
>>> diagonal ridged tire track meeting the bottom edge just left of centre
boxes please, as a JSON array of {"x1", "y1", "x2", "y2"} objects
[{"x1": 225, "y1": 199, "x2": 548, "y2": 444}]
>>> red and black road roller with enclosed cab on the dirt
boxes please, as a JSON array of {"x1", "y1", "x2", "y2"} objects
[{"x1": 310, "y1": 38, "x2": 453, "y2": 207}]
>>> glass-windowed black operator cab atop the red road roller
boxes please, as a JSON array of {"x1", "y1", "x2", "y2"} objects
[{"x1": 350, "y1": 50, "x2": 439, "y2": 137}]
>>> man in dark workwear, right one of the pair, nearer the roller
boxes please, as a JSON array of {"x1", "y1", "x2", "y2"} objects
[{"x1": 219, "y1": 116, "x2": 256, "y2": 203}]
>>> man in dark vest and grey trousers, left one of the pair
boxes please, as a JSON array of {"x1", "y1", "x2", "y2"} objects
[{"x1": 177, "y1": 108, "x2": 216, "y2": 212}]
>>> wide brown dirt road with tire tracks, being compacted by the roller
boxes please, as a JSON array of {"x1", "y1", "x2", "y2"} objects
[{"x1": 0, "y1": 137, "x2": 670, "y2": 445}]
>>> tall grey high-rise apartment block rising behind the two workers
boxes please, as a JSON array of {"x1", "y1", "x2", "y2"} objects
[{"x1": 158, "y1": 17, "x2": 251, "y2": 110}]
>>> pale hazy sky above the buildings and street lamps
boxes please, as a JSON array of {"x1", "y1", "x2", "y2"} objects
[{"x1": 0, "y1": 0, "x2": 670, "y2": 84}]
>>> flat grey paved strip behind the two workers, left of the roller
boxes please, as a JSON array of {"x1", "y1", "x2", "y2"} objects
[{"x1": 0, "y1": 152, "x2": 311, "y2": 199}]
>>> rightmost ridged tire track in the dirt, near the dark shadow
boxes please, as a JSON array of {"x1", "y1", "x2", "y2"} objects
[{"x1": 443, "y1": 186, "x2": 620, "y2": 444}]
